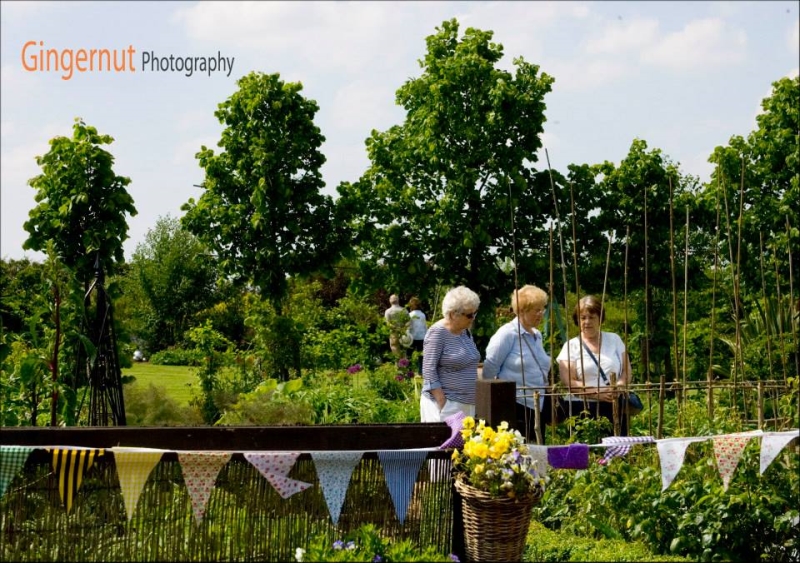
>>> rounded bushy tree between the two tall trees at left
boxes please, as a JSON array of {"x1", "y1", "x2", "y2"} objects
[{"x1": 124, "y1": 215, "x2": 216, "y2": 354}]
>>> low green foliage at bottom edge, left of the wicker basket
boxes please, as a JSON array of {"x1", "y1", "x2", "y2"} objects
[{"x1": 295, "y1": 524, "x2": 458, "y2": 563}]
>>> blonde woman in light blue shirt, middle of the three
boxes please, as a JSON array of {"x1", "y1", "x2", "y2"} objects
[{"x1": 483, "y1": 285, "x2": 553, "y2": 444}]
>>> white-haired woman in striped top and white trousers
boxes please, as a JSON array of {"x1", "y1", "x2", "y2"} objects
[{"x1": 420, "y1": 286, "x2": 481, "y2": 422}]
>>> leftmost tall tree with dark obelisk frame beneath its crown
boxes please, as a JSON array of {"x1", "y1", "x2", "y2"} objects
[{"x1": 23, "y1": 118, "x2": 136, "y2": 425}]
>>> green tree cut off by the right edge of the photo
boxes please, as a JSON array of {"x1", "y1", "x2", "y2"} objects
[{"x1": 704, "y1": 77, "x2": 800, "y2": 298}]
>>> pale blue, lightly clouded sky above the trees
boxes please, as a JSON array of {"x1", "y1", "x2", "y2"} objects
[{"x1": 0, "y1": 1, "x2": 800, "y2": 261}]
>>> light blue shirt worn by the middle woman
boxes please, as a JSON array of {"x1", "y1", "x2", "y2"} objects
[{"x1": 483, "y1": 318, "x2": 550, "y2": 409}]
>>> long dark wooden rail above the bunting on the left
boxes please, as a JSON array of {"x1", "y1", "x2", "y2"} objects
[{"x1": 0, "y1": 422, "x2": 451, "y2": 451}]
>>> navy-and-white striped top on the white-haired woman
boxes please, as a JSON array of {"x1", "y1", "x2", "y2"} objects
[{"x1": 422, "y1": 320, "x2": 481, "y2": 405}]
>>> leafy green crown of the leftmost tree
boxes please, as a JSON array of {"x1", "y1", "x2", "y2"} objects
[{"x1": 23, "y1": 118, "x2": 136, "y2": 283}]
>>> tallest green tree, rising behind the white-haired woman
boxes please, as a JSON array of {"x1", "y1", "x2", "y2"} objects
[{"x1": 337, "y1": 19, "x2": 553, "y2": 332}]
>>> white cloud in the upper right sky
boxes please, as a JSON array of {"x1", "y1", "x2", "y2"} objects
[{"x1": 641, "y1": 18, "x2": 747, "y2": 70}]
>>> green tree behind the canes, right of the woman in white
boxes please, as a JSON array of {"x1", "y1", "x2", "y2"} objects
[{"x1": 582, "y1": 139, "x2": 700, "y2": 379}]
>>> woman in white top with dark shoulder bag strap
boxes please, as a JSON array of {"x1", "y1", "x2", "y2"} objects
[{"x1": 556, "y1": 295, "x2": 631, "y2": 436}]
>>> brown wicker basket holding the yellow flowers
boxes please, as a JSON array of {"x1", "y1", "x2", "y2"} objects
[{"x1": 455, "y1": 478, "x2": 542, "y2": 561}]
